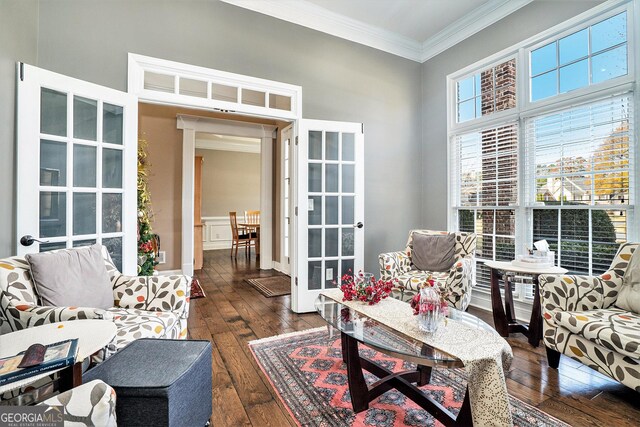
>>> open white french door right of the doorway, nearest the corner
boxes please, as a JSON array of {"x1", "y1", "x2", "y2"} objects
[{"x1": 291, "y1": 119, "x2": 364, "y2": 313}]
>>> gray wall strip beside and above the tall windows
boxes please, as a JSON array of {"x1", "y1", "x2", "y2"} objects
[{"x1": 422, "y1": 0, "x2": 602, "y2": 230}]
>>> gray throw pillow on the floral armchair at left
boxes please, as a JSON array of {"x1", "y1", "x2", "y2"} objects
[{"x1": 25, "y1": 244, "x2": 113, "y2": 309}]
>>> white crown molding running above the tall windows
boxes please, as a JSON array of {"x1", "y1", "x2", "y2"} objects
[{"x1": 420, "y1": 0, "x2": 533, "y2": 62}]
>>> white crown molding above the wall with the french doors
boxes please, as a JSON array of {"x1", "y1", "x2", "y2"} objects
[{"x1": 220, "y1": 0, "x2": 422, "y2": 62}]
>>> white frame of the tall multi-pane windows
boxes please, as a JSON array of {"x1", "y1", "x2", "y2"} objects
[{"x1": 447, "y1": 0, "x2": 640, "y2": 318}]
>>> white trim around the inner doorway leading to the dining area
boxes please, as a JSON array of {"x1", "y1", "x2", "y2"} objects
[{"x1": 177, "y1": 114, "x2": 277, "y2": 276}]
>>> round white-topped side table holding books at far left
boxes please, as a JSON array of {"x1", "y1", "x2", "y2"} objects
[{"x1": 0, "y1": 319, "x2": 116, "y2": 394}]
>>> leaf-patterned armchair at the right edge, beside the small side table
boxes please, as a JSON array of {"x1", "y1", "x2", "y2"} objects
[{"x1": 539, "y1": 243, "x2": 640, "y2": 392}]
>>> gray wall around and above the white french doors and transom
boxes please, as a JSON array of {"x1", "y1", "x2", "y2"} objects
[{"x1": 17, "y1": 0, "x2": 421, "y2": 271}]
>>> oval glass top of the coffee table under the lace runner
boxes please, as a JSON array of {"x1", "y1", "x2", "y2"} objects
[{"x1": 315, "y1": 295, "x2": 496, "y2": 367}]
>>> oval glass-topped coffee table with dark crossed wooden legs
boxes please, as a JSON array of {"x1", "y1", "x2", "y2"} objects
[{"x1": 315, "y1": 295, "x2": 496, "y2": 426}]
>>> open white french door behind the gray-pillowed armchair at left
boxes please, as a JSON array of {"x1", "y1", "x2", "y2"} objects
[{"x1": 16, "y1": 64, "x2": 138, "y2": 275}]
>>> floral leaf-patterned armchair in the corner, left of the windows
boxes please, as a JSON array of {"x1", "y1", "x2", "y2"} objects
[{"x1": 378, "y1": 230, "x2": 476, "y2": 310}]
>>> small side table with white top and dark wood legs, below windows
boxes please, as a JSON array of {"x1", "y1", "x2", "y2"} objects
[{"x1": 484, "y1": 261, "x2": 567, "y2": 347}]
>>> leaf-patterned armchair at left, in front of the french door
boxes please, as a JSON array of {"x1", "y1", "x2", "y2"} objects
[{"x1": 0, "y1": 247, "x2": 191, "y2": 356}]
